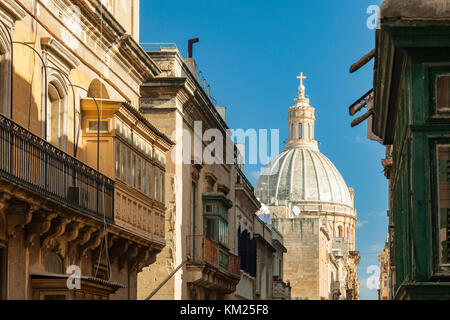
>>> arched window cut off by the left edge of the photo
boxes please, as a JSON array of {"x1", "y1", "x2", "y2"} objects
[{"x1": 0, "y1": 25, "x2": 11, "y2": 117}]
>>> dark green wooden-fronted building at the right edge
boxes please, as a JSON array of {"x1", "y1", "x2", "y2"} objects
[{"x1": 355, "y1": 0, "x2": 450, "y2": 300}]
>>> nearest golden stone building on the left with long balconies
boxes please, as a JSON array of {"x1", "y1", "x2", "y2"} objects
[{"x1": 0, "y1": 0, "x2": 173, "y2": 300}]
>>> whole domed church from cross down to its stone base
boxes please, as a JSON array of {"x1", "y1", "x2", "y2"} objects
[{"x1": 255, "y1": 74, "x2": 359, "y2": 299}]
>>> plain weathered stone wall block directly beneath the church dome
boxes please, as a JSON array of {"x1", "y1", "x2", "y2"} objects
[{"x1": 273, "y1": 217, "x2": 320, "y2": 299}]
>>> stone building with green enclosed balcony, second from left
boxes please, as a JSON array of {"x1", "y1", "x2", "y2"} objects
[{"x1": 139, "y1": 46, "x2": 243, "y2": 300}]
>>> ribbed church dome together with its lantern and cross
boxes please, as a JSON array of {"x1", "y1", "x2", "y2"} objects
[{"x1": 255, "y1": 74, "x2": 354, "y2": 214}]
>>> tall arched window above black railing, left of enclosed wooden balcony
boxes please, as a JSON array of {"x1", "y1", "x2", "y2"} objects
[{"x1": 47, "y1": 75, "x2": 68, "y2": 151}]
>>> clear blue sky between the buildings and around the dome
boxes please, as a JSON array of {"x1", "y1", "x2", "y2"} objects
[{"x1": 141, "y1": 0, "x2": 388, "y2": 299}]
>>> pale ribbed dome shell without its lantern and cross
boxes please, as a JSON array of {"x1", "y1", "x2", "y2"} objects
[{"x1": 255, "y1": 146, "x2": 353, "y2": 207}]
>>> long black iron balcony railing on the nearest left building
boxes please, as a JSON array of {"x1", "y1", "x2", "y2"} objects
[{"x1": 0, "y1": 115, "x2": 114, "y2": 223}]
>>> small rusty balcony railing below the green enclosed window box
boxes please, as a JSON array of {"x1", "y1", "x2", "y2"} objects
[{"x1": 187, "y1": 235, "x2": 241, "y2": 276}]
